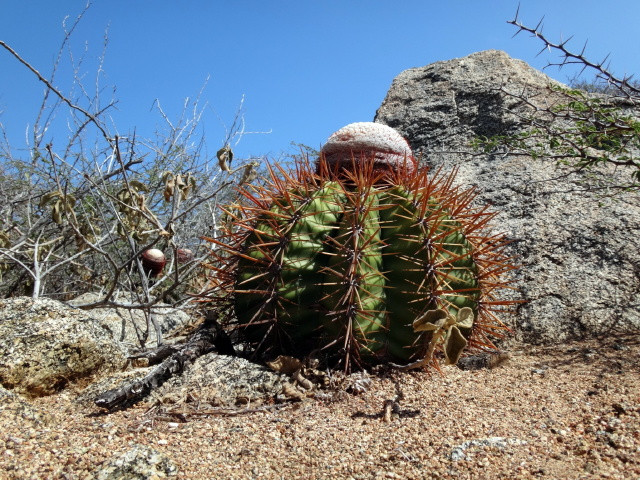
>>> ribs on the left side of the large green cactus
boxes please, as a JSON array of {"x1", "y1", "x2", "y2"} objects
[{"x1": 235, "y1": 184, "x2": 340, "y2": 343}]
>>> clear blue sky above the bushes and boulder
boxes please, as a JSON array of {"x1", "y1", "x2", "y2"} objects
[{"x1": 0, "y1": 0, "x2": 640, "y2": 163}]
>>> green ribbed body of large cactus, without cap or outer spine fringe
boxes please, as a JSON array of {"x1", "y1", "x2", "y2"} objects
[{"x1": 235, "y1": 181, "x2": 478, "y2": 363}]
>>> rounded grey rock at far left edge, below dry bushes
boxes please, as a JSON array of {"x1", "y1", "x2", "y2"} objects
[{"x1": 0, "y1": 297, "x2": 126, "y2": 396}]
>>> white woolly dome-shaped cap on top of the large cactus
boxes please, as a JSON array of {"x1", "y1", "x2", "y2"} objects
[{"x1": 321, "y1": 122, "x2": 415, "y2": 170}]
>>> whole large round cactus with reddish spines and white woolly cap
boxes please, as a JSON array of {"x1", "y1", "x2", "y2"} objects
[{"x1": 204, "y1": 123, "x2": 513, "y2": 370}]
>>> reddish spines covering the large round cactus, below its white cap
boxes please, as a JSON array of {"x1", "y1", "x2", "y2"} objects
[{"x1": 202, "y1": 159, "x2": 514, "y2": 369}]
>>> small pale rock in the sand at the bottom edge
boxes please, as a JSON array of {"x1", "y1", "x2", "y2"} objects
[{"x1": 95, "y1": 445, "x2": 178, "y2": 480}]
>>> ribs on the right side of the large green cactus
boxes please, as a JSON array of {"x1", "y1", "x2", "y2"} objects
[{"x1": 381, "y1": 187, "x2": 478, "y2": 359}]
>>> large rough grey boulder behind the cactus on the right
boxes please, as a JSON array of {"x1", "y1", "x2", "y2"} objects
[{"x1": 375, "y1": 51, "x2": 640, "y2": 343}]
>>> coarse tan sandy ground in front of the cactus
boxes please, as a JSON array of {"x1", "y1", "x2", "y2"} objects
[{"x1": 0, "y1": 335, "x2": 640, "y2": 480}]
